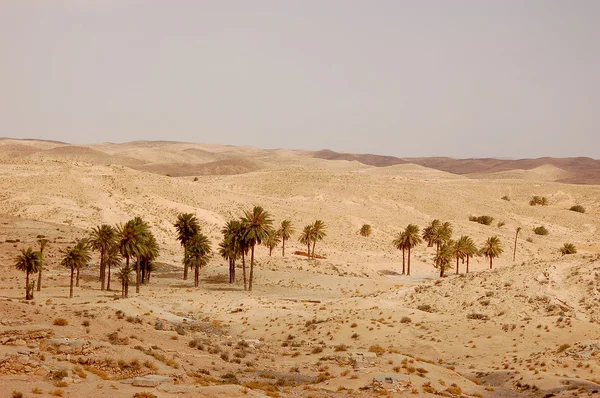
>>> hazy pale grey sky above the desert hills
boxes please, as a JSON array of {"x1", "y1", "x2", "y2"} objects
[{"x1": 0, "y1": 0, "x2": 600, "y2": 158}]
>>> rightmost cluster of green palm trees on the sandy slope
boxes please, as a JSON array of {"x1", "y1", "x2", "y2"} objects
[{"x1": 392, "y1": 219, "x2": 503, "y2": 277}]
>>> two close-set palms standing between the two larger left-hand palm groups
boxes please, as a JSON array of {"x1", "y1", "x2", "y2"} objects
[{"x1": 174, "y1": 213, "x2": 212, "y2": 287}]
